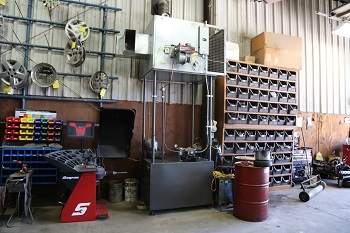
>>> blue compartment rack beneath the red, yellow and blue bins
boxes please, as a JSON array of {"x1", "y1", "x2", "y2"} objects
[{"x1": 0, "y1": 147, "x2": 59, "y2": 185}]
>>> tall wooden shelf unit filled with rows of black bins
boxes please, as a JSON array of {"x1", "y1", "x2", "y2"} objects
[{"x1": 215, "y1": 60, "x2": 298, "y2": 190}]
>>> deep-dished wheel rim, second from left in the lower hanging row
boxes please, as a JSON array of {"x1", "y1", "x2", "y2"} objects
[{"x1": 30, "y1": 63, "x2": 57, "y2": 87}]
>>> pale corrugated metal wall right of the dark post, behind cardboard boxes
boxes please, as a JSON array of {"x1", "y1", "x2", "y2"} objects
[{"x1": 213, "y1": 0, "x2": 350, "y2": 114}]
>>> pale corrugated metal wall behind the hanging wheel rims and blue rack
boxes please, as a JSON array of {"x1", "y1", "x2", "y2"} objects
[{"x1": 0, "y1": 0, "x2": 203, "y2": 104}]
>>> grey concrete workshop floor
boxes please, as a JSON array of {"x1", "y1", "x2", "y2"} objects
[{"x1": 0, "y1": 177, "x2": 350, "y2": 233}]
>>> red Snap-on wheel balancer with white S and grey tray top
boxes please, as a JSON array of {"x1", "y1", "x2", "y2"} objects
[{"x1": 44, "y1": 150, "x2": 126, "y2": 223}]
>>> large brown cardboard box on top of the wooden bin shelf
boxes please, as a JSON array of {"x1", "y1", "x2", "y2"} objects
[{"x1": 251, "y1": 32, "x2": 302, "y2": 70}]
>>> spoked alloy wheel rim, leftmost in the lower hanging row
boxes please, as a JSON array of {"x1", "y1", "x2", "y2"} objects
[{"x1": 0, "y1": 60, "x2": 28, "y2": 89}]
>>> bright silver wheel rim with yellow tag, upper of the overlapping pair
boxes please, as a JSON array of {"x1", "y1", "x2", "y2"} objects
[{"x1": 65, "y1": 19, "x2": 90, "y2": 42}]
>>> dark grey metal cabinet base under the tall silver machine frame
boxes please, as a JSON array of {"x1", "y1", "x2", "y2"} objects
[{"x1": 140, "y1": 159, "x2": 214, "y2": 212}]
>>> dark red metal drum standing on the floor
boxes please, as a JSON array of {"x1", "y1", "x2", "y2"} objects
[{"x1": 233, "y1": 162, "x2": 269, "y2": 222}]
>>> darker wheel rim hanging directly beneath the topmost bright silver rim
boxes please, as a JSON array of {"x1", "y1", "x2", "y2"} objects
[{"x1": 64, "y1": 38, "x2": 86, "y2": 67}]
